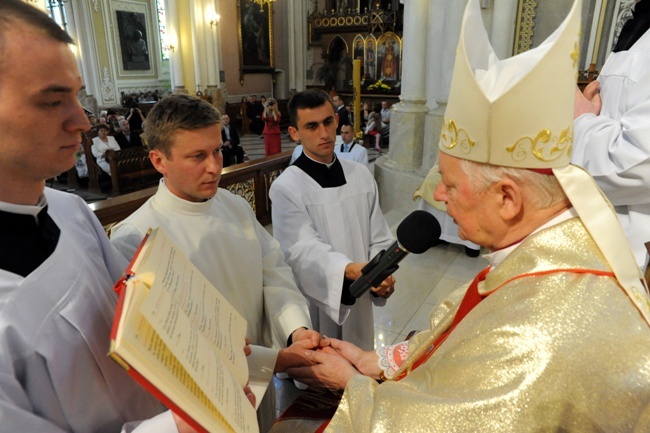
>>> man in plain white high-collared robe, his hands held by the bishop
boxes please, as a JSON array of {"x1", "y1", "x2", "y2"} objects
[{"x1": 111, "y1": 95, "x2": 320, "y2": 428}]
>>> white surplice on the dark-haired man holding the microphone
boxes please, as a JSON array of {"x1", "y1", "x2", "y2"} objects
[{"x1": 269, "y1": 160, "x2": 394, "y2": 349}]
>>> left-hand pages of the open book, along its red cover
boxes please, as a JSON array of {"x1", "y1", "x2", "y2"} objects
[{"x1": 111, "y1": 279, "x2": 254, "y2": 433}]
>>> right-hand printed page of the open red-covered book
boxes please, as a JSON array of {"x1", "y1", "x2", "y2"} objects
[{"x1": 129, "y1": 230, "x2": 256, "y2": 429}]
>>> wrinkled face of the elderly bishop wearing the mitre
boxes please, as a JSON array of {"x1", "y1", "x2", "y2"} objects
[{"x1": 433, "y1": 152, "x2": 498, "y2": 248}]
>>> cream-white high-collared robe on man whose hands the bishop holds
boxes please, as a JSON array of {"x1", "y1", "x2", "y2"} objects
[{"x1": 111, "y1": 179, "x2": 311, "y2": 392}]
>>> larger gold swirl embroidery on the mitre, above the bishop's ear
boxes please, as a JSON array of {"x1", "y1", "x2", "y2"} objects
[{"x1": 506, "y1": 126, "x2": 573, "y2": 162}]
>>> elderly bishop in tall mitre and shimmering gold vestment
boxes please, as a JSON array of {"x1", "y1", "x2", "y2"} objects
[{"x1": 280, "y1": 0, "x2": 650, "y2": 433}]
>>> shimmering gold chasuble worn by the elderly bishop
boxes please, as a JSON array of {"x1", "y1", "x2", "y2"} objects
[{"x1": 326, "y1": 218, "x2": 650, "y2": 433}]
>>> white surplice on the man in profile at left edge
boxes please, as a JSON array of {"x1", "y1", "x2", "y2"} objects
[{"x1": 0, "y1": 188, "x2": 166, "y2": 433}]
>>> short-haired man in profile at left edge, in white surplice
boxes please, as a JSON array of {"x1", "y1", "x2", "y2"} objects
[{"x1": 0, "y1": 0, "x2": 177, "y2": 433}]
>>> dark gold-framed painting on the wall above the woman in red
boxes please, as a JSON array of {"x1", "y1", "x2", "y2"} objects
[{"x1": 237, "y1": 0, "x2": 275, "y2": 74}]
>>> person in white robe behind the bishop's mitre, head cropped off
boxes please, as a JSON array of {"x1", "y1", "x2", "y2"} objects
[{"x1": 571, "y1": 0, "x2": 650, "y2": 268}]
